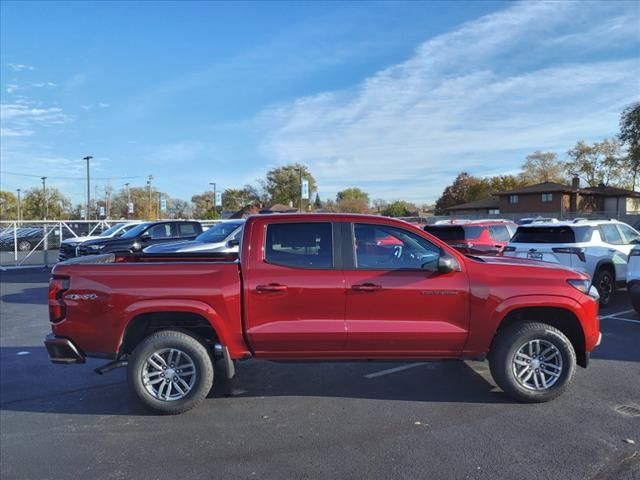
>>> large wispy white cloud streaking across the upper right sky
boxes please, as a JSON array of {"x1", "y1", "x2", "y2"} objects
[{"x1": 260, "y1": 2, "x2": 640, "y2": 201}]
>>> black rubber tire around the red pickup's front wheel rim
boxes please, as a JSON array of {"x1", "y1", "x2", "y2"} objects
[{"x1": 489, "y1": 322, "x2": 576, "y2": 403}]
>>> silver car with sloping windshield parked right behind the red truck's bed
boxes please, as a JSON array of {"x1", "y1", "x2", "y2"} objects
[{"x1": 143, "y1": 220, "x2": 244, "y2": 253}]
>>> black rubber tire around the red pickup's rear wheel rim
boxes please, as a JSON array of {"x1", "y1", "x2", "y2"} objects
[{"x1": 127, "y1": 330, "x2": 214, "y2": 415}]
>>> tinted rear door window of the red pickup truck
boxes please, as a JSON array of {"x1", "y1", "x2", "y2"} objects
[{"x1": 265, "y1": 222, "x2": 333, "y2": 268}]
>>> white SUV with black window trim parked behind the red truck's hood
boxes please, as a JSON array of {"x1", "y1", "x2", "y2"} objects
[{"x1": 503, "y1": 219, "x2": 640, "y2": 306}]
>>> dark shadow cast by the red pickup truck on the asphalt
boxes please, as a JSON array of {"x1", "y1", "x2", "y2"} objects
[{"x1": 0, "y1": 347, "x2": 513, "y2": 416}]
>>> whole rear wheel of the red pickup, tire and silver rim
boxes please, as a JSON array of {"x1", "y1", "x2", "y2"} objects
[{"x1": 127, "y1": 330, "x2": 214, "y2": 415}]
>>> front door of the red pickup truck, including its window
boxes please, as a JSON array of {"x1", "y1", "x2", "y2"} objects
[{"x1": 344, "y1": 223, "x2": 469, "y2": 357}]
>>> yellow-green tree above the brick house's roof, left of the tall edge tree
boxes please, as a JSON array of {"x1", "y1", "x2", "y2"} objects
[{"x1": 567, "y1": 138, "x2": 625, "y2": 187}]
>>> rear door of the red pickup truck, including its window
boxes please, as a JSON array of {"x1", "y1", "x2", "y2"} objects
[{"x1": 243, "y1": 219, "x2": 346, "y2": 358}]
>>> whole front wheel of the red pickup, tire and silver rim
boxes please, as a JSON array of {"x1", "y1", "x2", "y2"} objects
[{"x1": 489, "y1": 322, "x2": 576, "y2": 403}]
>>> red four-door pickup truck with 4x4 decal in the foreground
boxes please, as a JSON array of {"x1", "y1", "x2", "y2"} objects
[{"x1": 45, "y1": 214, "x2": 600, "y2": 413}]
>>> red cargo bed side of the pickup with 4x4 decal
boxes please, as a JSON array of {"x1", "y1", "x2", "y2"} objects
[{"x1": 52, "y1": 253, "x2": 246, "y2": 358}]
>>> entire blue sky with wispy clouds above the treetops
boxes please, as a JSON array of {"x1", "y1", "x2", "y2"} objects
[{"x1": 0, "y1": 1, "x2": 640, "y2": 203}]
